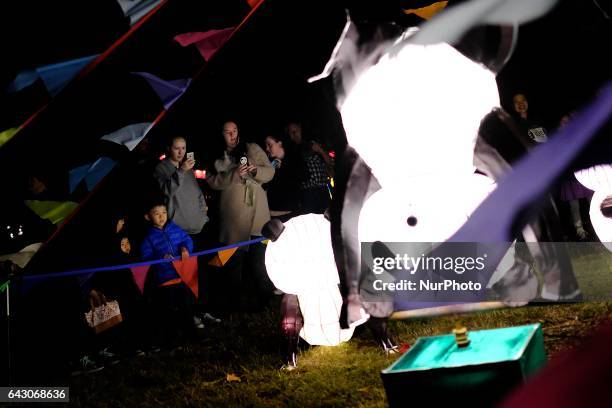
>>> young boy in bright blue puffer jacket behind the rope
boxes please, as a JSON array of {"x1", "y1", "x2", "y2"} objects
[{"x1": 140, "y1": 200, "x2": 204, "y2": 348}]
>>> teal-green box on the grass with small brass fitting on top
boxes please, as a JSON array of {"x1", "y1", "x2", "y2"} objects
[{"x1": 381, "y1": 324, "x2": 546, "y2": 407}]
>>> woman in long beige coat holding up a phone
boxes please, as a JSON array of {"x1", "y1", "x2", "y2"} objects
[{"x1": 207, "y1": 122, "x2": 274, "y2": 244}]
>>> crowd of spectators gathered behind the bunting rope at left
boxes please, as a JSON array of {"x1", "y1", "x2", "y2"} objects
[{"x1": 50, "y1": 121, "x2": 333, "y2": 374}]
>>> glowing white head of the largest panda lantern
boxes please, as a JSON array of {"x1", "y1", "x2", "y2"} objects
[{"x1": 341, "y1": 43, "x2": 499, "y2": 190}]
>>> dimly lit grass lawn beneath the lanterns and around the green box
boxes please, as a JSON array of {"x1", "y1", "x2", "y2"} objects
[{"x1": 70, "y1": 246, "x2": 612, "y2": 407}]
